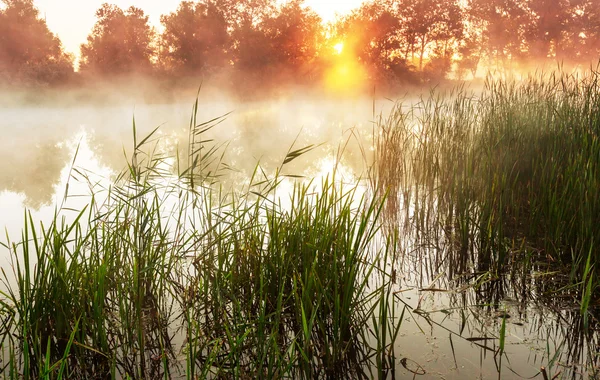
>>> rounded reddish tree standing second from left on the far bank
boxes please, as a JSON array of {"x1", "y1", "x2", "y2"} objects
[{"x1": 80, "y1": 3, "x2": 155, "y2": 75}]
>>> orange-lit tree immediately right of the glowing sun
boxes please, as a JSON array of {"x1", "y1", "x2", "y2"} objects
[{"x1": 338, "y1": 0, "x2": 464, "y2": 83}]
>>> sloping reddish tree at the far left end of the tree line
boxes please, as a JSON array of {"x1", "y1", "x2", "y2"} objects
[{"x1": 0, "y1": 0, "x2": 73, "y2": 85}]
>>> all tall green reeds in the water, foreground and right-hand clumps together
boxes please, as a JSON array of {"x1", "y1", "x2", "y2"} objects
[{"x1": 0, "y1": 67, "x2": 600, "y2": 379}]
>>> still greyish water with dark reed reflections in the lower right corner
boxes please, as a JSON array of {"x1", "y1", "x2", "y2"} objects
[{"x1": 396, "y1": 255, "x2": 600, "y2": 379}]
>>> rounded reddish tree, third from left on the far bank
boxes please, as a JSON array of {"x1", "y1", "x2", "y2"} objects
[{"x1": 159, "y1": 1, "x2": 231, "y2": 74}]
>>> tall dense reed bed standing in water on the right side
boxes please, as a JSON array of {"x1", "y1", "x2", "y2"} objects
[{"x1": 372, "y1": 70, "x2": 600, "y2": 314}]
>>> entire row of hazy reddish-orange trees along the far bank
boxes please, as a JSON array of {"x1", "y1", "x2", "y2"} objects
[{"x1": 0, "y1": 0, "x2": 600, "y2": 91}]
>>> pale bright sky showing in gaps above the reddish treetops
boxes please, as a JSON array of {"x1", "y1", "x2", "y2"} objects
[{"x1": 34, "y1": 0, "x2": 363, "y2": 56}]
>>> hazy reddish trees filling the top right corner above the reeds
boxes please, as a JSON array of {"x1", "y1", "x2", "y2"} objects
[{"x1": 461, "y1": 0, "x2": 600, "y2": 69}]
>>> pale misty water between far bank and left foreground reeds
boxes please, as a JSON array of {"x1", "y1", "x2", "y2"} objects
[{"x1": 0, "y1": 89, "x2": 393, "y2": 233}]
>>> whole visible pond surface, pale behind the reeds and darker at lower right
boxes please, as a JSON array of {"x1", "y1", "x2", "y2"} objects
[{"x1": 0, "y1": 100, "x2": 600, "y2": 379}]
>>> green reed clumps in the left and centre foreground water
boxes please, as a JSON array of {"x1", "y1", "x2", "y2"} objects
[{"x1": 0, "y1": 104, "x2": 398, "y2": 379}]
